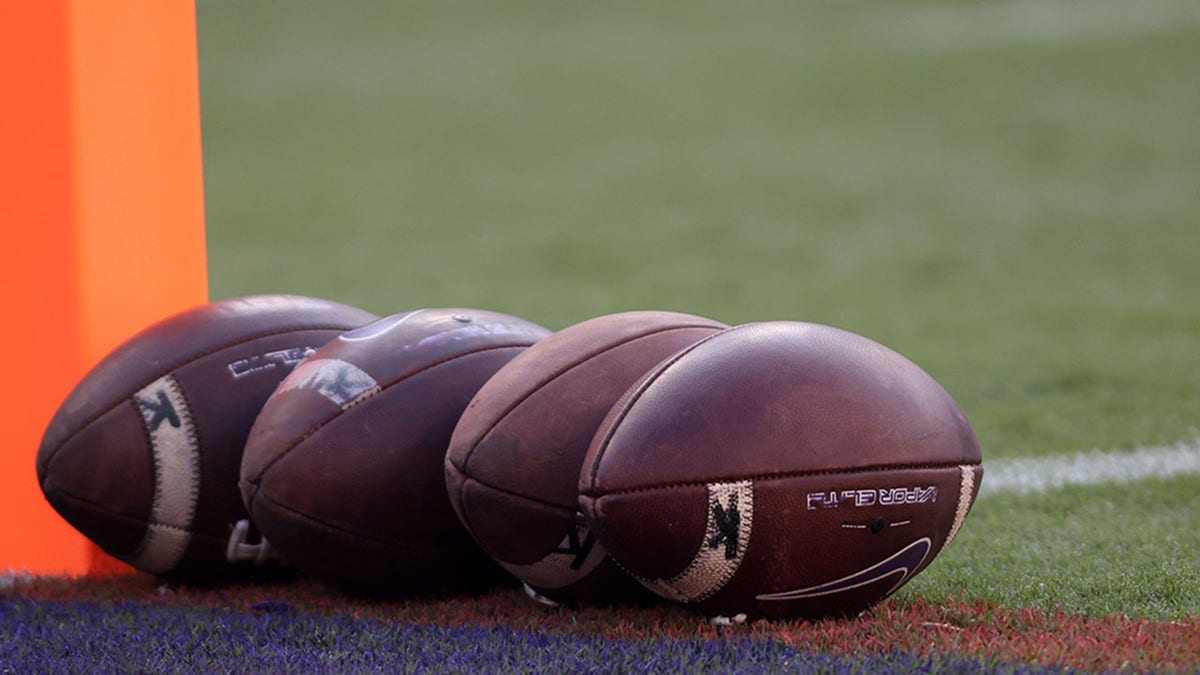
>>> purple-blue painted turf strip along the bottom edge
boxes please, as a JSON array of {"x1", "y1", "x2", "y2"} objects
[{"x1": 0, "y1": 598, "x2": 1067, "y2": 673}]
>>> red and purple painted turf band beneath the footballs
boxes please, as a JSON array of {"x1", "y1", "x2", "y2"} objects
[{"x1": 0, "y1": 575, "x2": 1200, "y2": 673}]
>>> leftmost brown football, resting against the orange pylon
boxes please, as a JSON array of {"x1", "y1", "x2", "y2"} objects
[{"x1": 37, "y1": 295, "x2": 376, "y2": 581}]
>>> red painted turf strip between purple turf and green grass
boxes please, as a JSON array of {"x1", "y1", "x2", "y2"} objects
[{"x1": 0, "y1": 575, "x2": 1200, "y2": 671}]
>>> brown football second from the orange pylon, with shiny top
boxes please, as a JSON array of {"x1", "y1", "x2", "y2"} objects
[{"x1": 241, "y1": 309, "x2": 550, "y2": 597}]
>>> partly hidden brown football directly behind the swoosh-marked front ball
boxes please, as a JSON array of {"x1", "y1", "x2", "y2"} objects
[{"x1": 445, "y1": 311, "x2": 728, "y2": 603}]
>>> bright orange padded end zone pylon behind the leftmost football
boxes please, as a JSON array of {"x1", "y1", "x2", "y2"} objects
[{"x1": 0, "y1": 0, "x2": 208, "y2": 574}]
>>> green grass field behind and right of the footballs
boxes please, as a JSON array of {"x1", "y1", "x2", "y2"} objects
[{"x1": 198, "y1": 0, "x2": 1200, "y2": 620}]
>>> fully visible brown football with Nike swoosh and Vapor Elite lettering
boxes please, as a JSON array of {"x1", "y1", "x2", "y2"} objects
[{"x1": 580, "y1": 322, "x2": 983, "y2": 617}]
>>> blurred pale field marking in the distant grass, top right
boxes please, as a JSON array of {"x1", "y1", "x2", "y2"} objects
[{"x1": 864, "y1": 0, "x2": 1200, "y2": 53}]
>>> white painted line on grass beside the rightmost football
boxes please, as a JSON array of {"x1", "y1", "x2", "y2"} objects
[{"x1": 979, "y1": 437, "x2": 1200, "y2": 496}]
